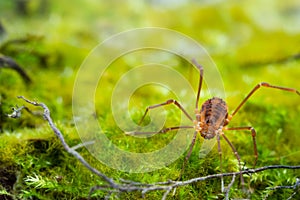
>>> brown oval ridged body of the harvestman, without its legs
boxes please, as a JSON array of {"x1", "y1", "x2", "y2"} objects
[{"x1": 200, "y1": 97, "x2": 228, "y2": 139}]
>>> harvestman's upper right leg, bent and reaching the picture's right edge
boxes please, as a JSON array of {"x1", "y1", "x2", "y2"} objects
[{"x1": 229, "y1": 82, "x2": 300, "y2": 120}]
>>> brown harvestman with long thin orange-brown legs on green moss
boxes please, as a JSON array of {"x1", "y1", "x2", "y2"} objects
[{"x1": 126, "y1": 60, "x2": 300, "y2": 183}]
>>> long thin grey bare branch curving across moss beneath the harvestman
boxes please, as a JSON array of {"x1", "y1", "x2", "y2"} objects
[{"x1": 18, "y1": 96, "x2": 300, "y2": 199}]
